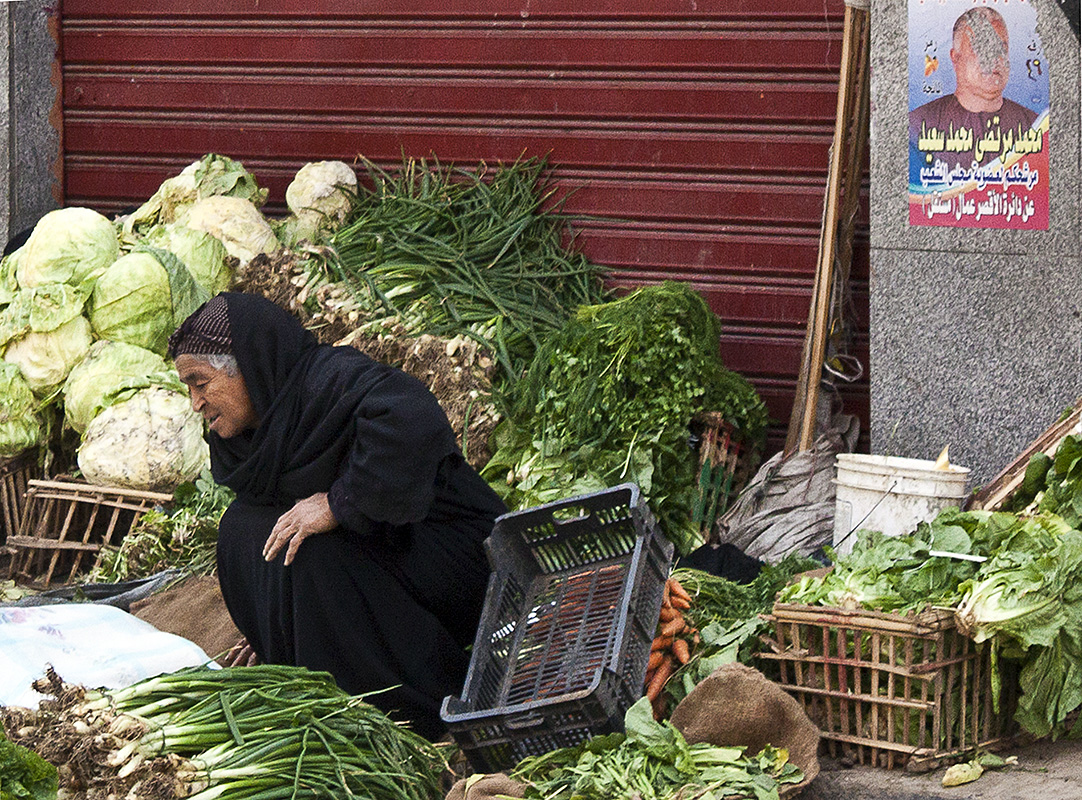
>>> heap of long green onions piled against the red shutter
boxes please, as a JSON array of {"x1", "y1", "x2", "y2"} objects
[{"x1": 313, "y1": 159, "x2": 604, "y2": 381}]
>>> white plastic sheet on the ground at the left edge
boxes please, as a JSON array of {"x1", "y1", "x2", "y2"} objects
[{"x1": 0, "y1": 603, "x2": 213, "y2": 708}]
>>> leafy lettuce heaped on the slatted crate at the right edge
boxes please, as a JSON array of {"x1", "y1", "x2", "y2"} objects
[{"x1": 779, "y1": 436, "x2": 1082, "y2": 737}]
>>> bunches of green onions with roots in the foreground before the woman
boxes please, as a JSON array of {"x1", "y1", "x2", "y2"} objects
[{"x1": 0, "y1": 666, "x2": 446, "y2": 800}]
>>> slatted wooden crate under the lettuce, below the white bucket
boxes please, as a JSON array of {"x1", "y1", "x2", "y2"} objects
[{"x1": 760, "y1": 604, "x2": 1017, "y2": 771}]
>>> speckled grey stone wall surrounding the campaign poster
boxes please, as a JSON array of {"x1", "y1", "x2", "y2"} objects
[{"x1": 870, "y1": 0, "x2": 1082, "y2": 488}]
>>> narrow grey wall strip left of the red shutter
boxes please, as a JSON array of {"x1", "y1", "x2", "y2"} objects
[{"x1": 0, "y1": 0, "x2": 60, "y2": 250}]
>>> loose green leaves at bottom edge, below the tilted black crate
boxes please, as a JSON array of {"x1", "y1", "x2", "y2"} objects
[{"x1": 511, "y1": 698, "x2": 804, "y2": 800}]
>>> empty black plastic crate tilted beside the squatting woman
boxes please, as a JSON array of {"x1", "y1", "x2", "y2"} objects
[{"x1": 441, "y1": 484, "x2": 673, "y2": 772}]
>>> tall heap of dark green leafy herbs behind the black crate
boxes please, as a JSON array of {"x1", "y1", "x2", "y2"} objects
[{"x1": 483, "y1": 281, "x2": 767, "y2": 553}]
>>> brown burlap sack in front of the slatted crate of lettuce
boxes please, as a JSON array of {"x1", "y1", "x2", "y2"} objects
[{"x1": 672, "y1": 664, "x2": 819, "y2": 797}]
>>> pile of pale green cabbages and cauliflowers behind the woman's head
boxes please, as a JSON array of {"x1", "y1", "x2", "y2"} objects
[{"x1": 0, "y1": 154, "x2": 356, "y2": 490}]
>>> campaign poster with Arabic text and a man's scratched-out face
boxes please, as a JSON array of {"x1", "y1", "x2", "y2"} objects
[{"x1": 909, "y1": 0, "x2": 1048, "y2": 231}]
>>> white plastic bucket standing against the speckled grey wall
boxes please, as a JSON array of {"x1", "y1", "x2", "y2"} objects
[{"x1": 833, "y1": 453, "x2": 969, "y2": 553}]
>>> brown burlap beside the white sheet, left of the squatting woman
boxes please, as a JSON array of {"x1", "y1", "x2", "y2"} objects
[{"x1": 131, "y1": 575, "x2": 240, "y2": 664}]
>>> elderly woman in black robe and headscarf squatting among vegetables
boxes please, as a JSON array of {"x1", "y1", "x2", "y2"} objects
[{"x1": 169, "y1": 293, "x2": 506, "y2": 738}]
